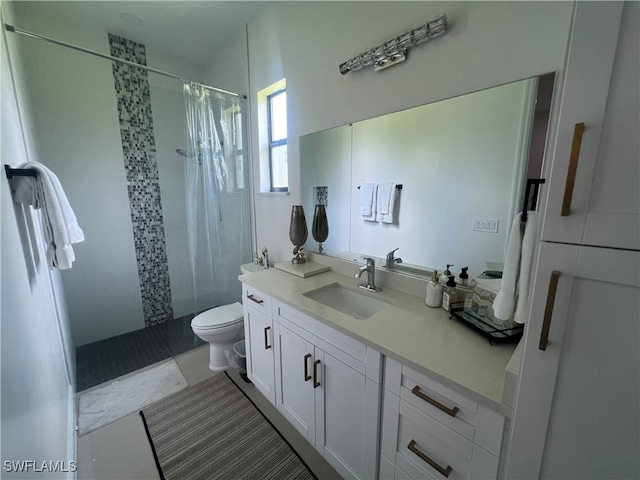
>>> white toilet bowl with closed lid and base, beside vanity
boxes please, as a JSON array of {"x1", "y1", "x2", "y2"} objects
[{"x1": 191, "y1": 302, "x2": 244, "y2": 372}]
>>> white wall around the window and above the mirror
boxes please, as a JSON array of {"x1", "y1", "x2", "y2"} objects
[{"x1": 236, "y1": 2, "x2": 572, "y2": 261}]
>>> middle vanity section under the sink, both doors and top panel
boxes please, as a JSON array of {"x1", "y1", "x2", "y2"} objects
[{"x1": 275, "y1": 302, "x2": 380, "y2": 479}]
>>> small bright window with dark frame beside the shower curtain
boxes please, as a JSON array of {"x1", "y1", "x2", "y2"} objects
[{"x1": 258, "y1": 79, "x2": 289, "y2": 193}]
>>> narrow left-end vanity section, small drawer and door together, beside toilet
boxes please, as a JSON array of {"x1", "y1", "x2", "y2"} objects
[{"x1": 242, "y1": 284, "x2": 276, "y2": 405}]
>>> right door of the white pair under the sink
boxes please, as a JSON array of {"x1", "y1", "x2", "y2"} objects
[{"x1": 314, "y1": 347, "x2": 380, "y2": 479}]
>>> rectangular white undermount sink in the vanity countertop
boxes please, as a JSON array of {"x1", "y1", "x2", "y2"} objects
[{"x1": 303, "y1": 283, "x2": 391, "y2": 320}]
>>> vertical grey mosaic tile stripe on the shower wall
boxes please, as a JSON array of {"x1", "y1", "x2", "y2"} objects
[{"x1": 109, "y1": 33, "x2": 173, "y2": 327}]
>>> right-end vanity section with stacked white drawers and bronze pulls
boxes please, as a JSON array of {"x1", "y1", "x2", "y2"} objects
[{"x1": 380, "y1": 358, "x2": 505, "y2": 479}]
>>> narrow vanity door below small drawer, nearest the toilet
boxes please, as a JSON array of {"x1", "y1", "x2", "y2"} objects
[{"x1": 244, "y1": 306, "x2": 276, "y2": 405}]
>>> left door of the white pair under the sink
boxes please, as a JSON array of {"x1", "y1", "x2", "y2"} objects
[{"x1": 275, "y1": 324, "x2": 316, "y2": 445}]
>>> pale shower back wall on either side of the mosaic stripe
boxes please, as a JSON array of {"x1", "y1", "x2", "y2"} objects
[{"x1": 9, "y1": 2, "x2": 201, "y2": 345}]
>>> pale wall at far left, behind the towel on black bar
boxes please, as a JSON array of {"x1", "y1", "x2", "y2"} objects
[{"x1": 0, "y1": 2, "x2": 75, "y2": 478}]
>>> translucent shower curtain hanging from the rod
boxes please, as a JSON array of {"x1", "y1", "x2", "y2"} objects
[{"x1": 184, "y1": 83, "x2": 252, "y2": 314}]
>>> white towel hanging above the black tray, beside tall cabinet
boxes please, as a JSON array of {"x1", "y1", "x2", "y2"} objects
[{"x1": 493, "y1": 212, "x2": 539, "y2": 323}]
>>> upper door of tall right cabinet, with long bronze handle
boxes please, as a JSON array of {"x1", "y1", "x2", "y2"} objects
[{"x1": 542, "y1": 2, "x2": 640, "y2": 249}]
